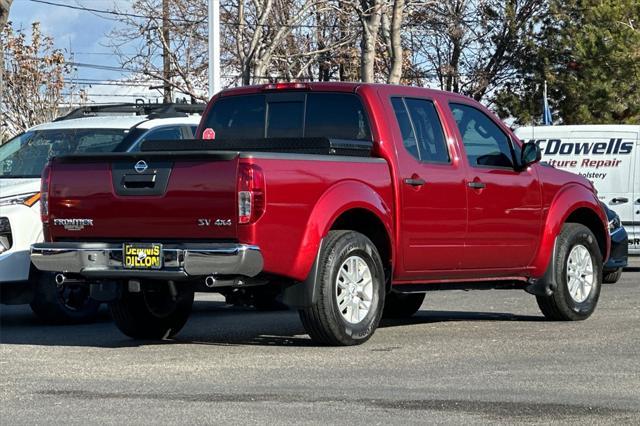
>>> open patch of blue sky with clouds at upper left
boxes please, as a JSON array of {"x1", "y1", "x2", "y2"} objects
[{"x1": 9, "y1": 0, "x2": 161, "y2": 102}]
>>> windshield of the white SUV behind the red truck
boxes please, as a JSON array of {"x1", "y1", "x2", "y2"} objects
[{"x1": 0, "y1": 129, "x2": 128, "y2": 178}]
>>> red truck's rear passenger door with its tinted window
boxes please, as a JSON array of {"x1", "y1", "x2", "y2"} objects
[{"x1": 390, "y1": 96, "x2": 467, "y2": 280}]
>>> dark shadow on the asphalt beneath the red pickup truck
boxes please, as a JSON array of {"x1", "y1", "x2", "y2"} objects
[{"x1": 0, "y1": 301, "x2": 544, "y2": 348}]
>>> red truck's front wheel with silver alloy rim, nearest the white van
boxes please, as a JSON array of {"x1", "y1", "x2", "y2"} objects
[{"x1": 537, "y1": 223, "x2": 602, "y2": 321}]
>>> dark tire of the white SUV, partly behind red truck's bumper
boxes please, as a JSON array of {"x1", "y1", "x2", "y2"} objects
[{"x1": 30, "y1": 272, "x2": 100, "y2": 324}]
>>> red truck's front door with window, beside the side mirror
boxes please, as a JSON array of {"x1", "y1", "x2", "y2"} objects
[{"x1": 449, "y1": 102, "x2": 542, "y2": 276}]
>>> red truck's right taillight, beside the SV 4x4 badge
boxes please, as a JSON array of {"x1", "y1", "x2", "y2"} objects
[{"x1": 238, "y1": 163, "x2": 265, "y2": 224}]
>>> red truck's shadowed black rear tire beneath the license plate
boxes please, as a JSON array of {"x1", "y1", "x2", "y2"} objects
[{"x1": 109, "y1": 280, "x2": 193, "y2": 340}]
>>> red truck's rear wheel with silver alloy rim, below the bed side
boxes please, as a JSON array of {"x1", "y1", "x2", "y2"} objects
[{"x1": 299, "y1": 231, "x2": 385, "y2": 346}]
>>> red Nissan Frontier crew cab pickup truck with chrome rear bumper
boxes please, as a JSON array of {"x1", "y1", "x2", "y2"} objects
[{"x1": 31, "y1": 83, "x2": 610, "y2": 345}]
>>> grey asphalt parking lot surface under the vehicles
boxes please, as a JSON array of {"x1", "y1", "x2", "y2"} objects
[{"x1": 0, "y1": 268, "x2": 640, "y2": 425}]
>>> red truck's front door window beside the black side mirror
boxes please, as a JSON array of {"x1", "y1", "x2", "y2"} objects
[{"x1": 450, "y1": 104, "x2": 514, "y2": 168}]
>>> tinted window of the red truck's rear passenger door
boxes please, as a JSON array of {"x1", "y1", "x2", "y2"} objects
[{"x1": 391, "y1": 98, "x2": 450, "y2": 163}]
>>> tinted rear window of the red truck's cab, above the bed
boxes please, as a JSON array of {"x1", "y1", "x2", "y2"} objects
[{"x1": 205, "y1": 92, "x2": 371, "y2": 140}]
